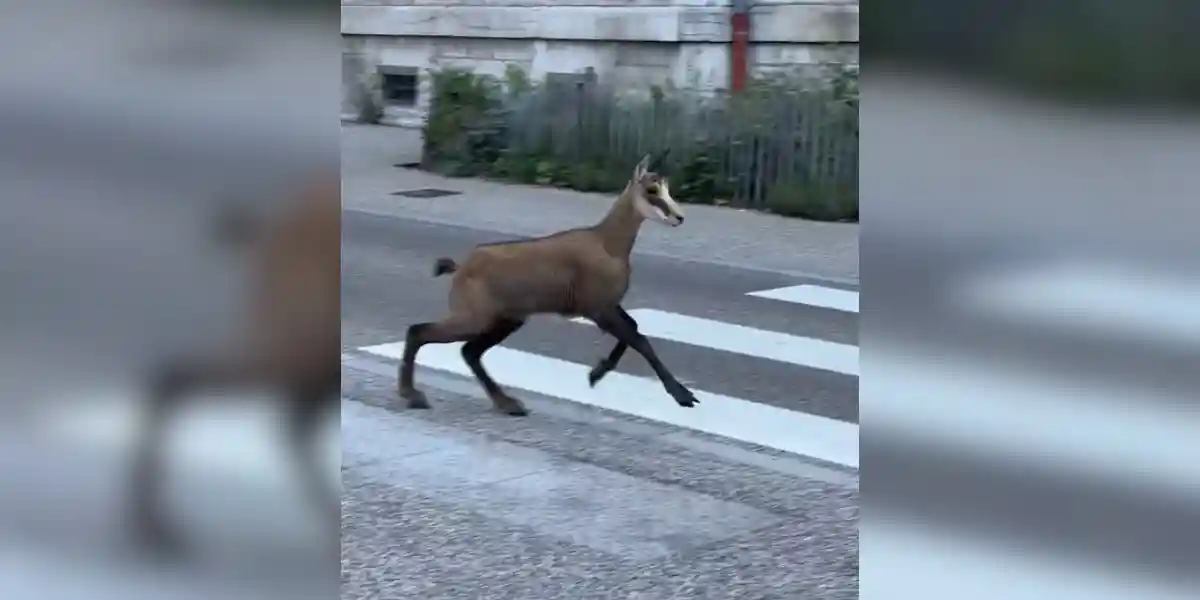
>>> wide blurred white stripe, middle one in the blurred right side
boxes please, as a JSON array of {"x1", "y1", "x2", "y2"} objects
[{"x1": 873, "y1": 347, "x2": 1200, "y2": 498}]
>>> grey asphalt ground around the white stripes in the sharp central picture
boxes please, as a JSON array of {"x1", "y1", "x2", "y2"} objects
[{"x1": 342, "y1": 205, "x2": 858, "y2": 599}]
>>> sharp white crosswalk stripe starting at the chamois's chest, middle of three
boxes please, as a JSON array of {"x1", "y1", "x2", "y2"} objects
[{"x1": 609, "y1": 308, "x2": 858, "y2": 377}]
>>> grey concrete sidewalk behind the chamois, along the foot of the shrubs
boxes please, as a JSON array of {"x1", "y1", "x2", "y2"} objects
[{"x1": 342, "y1": 124, "x2": 859, "y2": 284}]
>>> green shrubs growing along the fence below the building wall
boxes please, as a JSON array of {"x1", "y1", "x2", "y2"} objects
[{"x1": 421, "y1": 67, "x2": 858, "y2": 220}]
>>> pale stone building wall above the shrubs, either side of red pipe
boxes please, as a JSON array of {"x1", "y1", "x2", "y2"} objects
[{"x1": 342, "y1": 0, "x2": 858, "y2": 126}]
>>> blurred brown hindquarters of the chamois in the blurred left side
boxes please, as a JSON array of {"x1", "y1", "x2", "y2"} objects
[{"x1": 130, "y1": 175, "x2": 341, "y2": 553}]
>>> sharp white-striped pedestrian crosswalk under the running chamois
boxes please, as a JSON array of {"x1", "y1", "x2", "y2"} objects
[{"x1": 360, "y1": 284, "x2": 859, "y2": 469}]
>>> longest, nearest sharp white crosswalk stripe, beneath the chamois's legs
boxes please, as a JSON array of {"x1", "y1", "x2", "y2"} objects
[{"x1": 361, "y1": 342, "x2": 858, "y2": 469}]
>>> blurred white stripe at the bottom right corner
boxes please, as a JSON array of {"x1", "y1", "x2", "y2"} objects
[{"x1": 873, "y1": 518, "x2": 1196, "y2": 600}]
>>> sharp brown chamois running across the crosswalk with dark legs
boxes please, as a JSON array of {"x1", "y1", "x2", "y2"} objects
[{"x1": 397, "y1": 150, "x2": 698, "y2": 416}]
